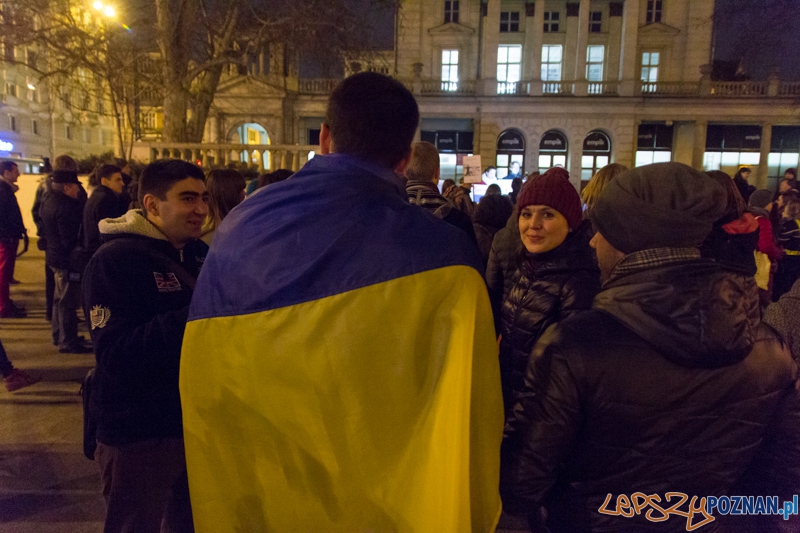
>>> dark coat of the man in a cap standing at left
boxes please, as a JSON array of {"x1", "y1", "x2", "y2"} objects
[{"x1": 39, "y1": 190, "x2": 83, "y2": 270}]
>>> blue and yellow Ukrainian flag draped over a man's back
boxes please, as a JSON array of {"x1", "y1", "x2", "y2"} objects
[{"x1": 180, "y1": 154, "x2": 503, "y2": 533}]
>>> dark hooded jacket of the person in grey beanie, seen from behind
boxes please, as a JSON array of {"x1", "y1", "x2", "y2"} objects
[{"x1": 501, "y1": 259, "x2": 800, "y2": 532}]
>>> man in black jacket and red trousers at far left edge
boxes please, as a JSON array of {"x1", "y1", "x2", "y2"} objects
[{"x1": 0, "y1": 161, "x2": 27, "y2": 318}]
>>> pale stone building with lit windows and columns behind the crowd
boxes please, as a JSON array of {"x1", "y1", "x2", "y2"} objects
[{"x1": 135, "y1": 0, "x2": 800, "y2": 191}]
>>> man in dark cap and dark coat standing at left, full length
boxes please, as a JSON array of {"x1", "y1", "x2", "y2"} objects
[{"x1": 39, "y1": 170, "x2": 92, "y2": 353}]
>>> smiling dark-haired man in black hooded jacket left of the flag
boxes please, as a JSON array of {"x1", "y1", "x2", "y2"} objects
[{"x1": 84, "y1": 160, "x2": 208, "y2": 533}]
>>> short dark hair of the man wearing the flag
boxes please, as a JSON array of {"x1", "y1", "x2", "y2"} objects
[{"x1": 325, "y1": 72, "x2": 419, "y2": 168}]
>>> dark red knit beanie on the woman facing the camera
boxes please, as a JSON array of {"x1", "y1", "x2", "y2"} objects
[{"x1": 517, "y1": 167, "x2": 583, "y2": 229}]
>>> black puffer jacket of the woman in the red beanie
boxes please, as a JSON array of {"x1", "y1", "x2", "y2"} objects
[{"x1": 500, "y1": 226, "x2": 600, "y2": 413}]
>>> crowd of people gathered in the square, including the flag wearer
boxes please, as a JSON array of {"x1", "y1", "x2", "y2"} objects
[{"x1": 0, "y1": 73, "x2": 800, "y2": 532}]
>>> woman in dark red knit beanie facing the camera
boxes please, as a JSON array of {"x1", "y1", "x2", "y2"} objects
[{"x1": 500, "y1": 168, "x2": 600, "y2": 418}]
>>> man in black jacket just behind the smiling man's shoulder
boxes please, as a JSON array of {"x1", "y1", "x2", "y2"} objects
[{"x1": 83, "y1": 165, "x2": 128, "y2": 257}]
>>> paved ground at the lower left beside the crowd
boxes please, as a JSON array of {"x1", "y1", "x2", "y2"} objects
[{"x1": 0, "y1": 247, "x2": 105, "y2": 533}]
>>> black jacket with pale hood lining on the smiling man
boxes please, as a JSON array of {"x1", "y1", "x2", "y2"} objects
[{"x1": 83, "y1": 211, "x2": 208, "y2": 446}]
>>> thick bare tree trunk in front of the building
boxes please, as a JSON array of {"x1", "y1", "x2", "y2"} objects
[{"x1": 156, "y1": 0, "x2": 199, "y2": 142}]
